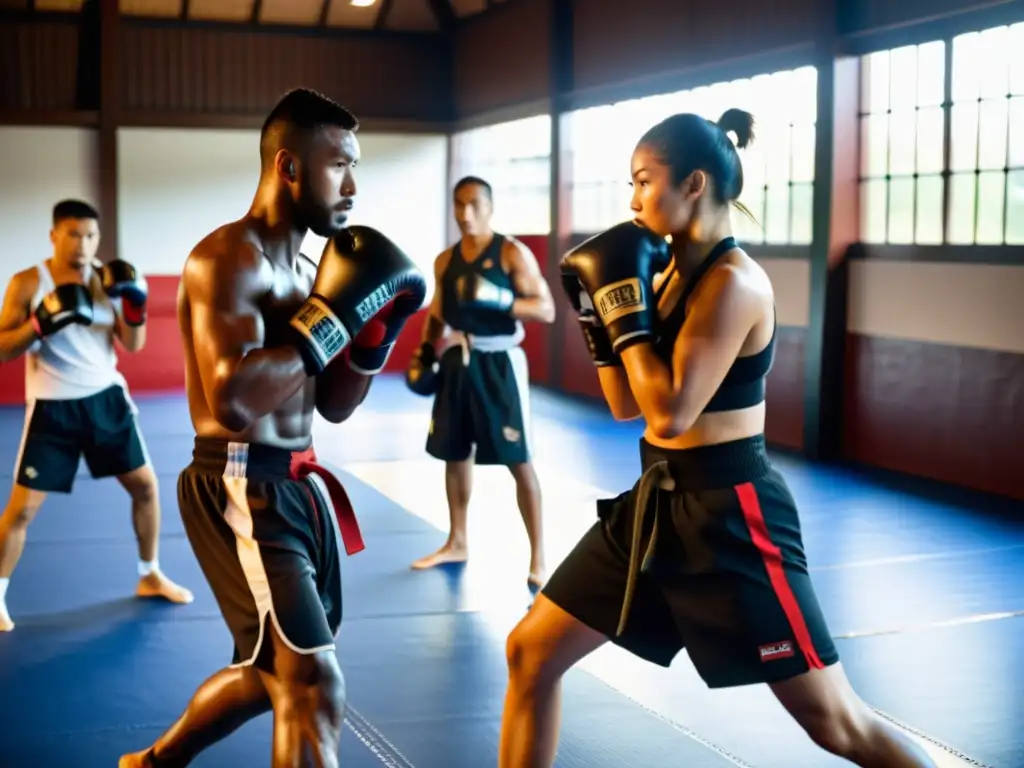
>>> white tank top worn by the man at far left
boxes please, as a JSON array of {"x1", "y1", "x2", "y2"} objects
[{"x1": 25, "y1": 262, "x2": 126, "y2": 401}]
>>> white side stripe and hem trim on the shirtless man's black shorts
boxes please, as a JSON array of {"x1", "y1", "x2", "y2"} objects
[{"x1": 222, "y1": 442, "x2": 341, "y2": 668}]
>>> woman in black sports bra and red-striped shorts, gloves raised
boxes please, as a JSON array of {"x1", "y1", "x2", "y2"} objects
[{"x1": 499, "y1": 110, "x2": 934, "y2": 768}]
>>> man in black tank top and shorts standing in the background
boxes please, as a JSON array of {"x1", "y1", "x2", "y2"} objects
[{"x1": 410, "y1": 176, "x2": 555, "y2": 588}]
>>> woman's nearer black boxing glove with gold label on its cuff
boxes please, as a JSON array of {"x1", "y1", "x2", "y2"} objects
[{"x1": 560, "y1": 221, "x2": 672, "y2": 356}]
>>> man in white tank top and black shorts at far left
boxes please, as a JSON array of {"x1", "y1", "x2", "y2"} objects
[{"x1": 0, "y1": 200, "x2": 193, "y2": 632}]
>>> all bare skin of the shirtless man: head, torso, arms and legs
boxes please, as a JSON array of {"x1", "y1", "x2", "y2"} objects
[{"x1": 119, "y1": 107, "x2": 371, "y2": 768}]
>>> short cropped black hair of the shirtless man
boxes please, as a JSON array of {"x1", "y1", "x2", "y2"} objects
[{"x1": 259, "y1": 88, "x2": 359, "y2": 168}]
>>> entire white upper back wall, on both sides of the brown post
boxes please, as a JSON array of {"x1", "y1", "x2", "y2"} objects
[{"x1": 0, "y1": 127, "x2": 447, "y2": 299}]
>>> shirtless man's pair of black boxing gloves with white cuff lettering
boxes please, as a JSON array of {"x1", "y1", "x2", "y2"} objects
[{"x1": 291, "y1": 226, "x2": 427, "y2": 376}]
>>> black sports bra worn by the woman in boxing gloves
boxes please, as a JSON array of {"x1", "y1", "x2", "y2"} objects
[{"x1": 654, "y1": 238, "x2": 775, "y2": 414}]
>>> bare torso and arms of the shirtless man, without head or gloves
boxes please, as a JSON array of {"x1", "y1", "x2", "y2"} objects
[{"x1": 178, "y1": 218, "x2": 371, "y2": 451}]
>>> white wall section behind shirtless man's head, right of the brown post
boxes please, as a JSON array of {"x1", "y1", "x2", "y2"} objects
[{"x1": 118, "y1": 128, "x2": 447, "y2": 296}]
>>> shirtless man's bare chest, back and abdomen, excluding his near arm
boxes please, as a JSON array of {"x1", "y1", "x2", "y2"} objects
[{"x1": 178, "y1": 219, "x2": 316, "y2": 450}]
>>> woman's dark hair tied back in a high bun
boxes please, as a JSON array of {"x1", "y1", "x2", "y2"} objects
[{"x1": 639, "y1": 109, "x2": 754, "y2": 220}]
